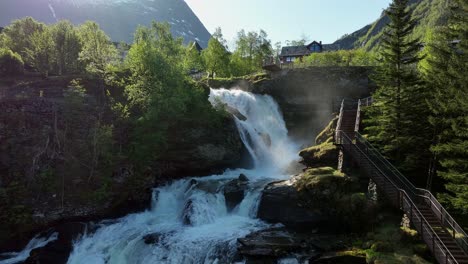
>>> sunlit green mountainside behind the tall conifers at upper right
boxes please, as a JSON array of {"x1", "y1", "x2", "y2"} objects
[{"x1": 333, "y1": 0, "x2": 449, "y2": 50}]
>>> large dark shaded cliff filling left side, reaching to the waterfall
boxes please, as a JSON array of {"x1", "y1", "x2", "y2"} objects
[{"x1": 0, "y1": 77, "x2": 246, "y2": 251}]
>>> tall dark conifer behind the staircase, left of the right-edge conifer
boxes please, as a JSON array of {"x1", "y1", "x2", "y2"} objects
[{"x1": 366, "y1": 0, "x2": 430, "y2": 178}]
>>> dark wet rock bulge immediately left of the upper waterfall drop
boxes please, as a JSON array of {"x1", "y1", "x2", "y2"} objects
[{"x1": 155, "y1": 116, "x2": 247, "y2": 178}]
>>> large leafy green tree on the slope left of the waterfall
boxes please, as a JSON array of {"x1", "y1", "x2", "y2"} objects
[{"x1": 125, "y1": 22, "x2": 227, "y2": 167}]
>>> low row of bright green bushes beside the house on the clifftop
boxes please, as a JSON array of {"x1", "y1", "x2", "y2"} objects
[{"x1": 303, "y1": 49, "x2": 377, "y2": 66}]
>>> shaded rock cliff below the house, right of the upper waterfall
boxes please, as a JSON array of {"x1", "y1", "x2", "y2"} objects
[{"x1": 254, "y1": 67, "x2": 372, "y2": 144}]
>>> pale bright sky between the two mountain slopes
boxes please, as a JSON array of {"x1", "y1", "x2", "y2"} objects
[{"x1": 185, "y1": 0, "x2": 391, "y2": 45}]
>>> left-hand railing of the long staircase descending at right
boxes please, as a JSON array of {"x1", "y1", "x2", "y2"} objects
[{"x1": 340, "y1": 131, "x2": 458, "y2": 264}]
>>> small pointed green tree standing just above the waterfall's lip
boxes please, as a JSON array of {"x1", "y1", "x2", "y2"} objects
[{"x1": 202, "y1": 28, "x2": 229, "y2": 78}]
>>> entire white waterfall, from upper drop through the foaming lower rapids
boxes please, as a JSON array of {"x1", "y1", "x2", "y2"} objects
[{"x1": 0, "y1": 89, "x2": 299, "y2": 264}]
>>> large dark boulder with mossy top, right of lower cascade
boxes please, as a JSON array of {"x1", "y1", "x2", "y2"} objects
[{"x1": 258, "y1": 167, "x2": 372, "y2": 231}]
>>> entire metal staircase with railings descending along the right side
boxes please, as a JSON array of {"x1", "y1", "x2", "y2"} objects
[{"x1": 335, "y1": 98, "x2": 468, "y2": 264}]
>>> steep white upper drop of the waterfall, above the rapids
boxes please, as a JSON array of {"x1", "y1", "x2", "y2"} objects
[{"x1": 209, "y1": 88, "x2": 299, "y2": 172}]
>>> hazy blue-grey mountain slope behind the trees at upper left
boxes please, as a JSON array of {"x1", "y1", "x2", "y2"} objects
[{"x1": 0, "y1": 0, "x2": 211, "y2": 47}]
